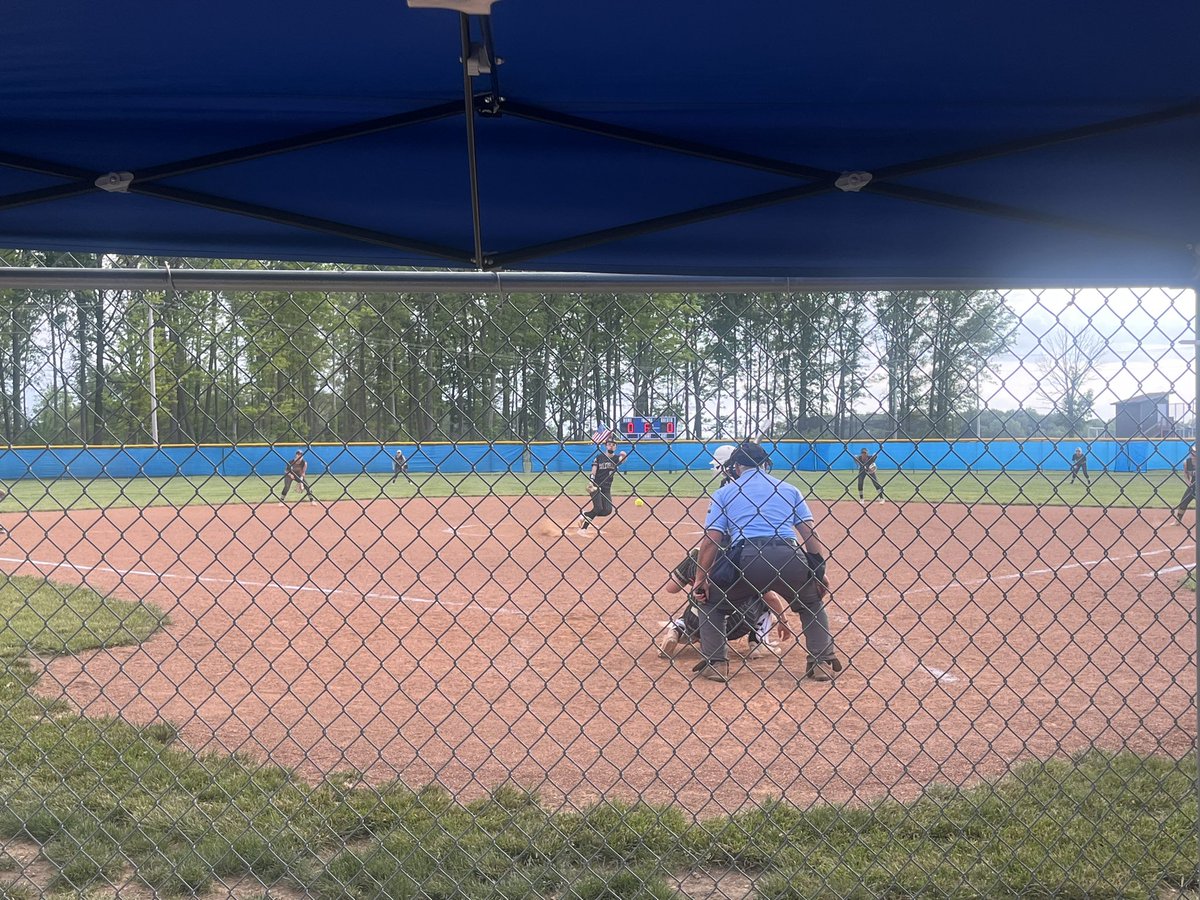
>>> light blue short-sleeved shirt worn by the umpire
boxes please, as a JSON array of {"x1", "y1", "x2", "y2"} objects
[{"x1": 704, "y1": 469, "x2": 812, "y2": 544}]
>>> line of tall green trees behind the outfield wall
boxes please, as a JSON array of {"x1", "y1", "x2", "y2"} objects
[{"x1": 0, "y1": 251, "x2": 1032, "y2": 444}]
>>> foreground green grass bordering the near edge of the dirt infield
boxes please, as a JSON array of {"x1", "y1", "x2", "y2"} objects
[{"x1": 0, "y1": 578, "x2": 1196, "y2": 900}]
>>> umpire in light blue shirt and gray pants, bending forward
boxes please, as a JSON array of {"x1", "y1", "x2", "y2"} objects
[{"x1": 692, "y1": 440, "x2": 842, "y2": 682}]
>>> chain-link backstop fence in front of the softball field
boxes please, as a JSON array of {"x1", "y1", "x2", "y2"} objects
[{"x1": 0, "y1": 260, "x2": 1196, "y2": 898}]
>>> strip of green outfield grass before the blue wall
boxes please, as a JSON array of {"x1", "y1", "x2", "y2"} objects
[{"x1": 0, "y1": 470, "x2": 1183, "y2": 512}]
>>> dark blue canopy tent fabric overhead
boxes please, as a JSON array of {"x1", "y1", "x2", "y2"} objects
[{"x1": 0, "y1": 0, "x2": 1200, "y2": 287}]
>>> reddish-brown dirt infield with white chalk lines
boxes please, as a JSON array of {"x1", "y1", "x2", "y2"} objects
[{"x1": 0, "y1": 497, "x2": 1195, "y2": 815}]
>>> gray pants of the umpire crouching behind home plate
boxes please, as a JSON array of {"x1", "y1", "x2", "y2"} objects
[{"x1": 700, "y1": 544, "x2": 833, "y2": 662}]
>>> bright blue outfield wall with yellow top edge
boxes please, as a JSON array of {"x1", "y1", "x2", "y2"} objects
[{"x1": 0, "y1": 439, "x2": 1189, "y2": 480}]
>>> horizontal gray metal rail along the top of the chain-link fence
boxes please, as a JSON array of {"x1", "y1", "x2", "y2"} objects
[{"x1": 0, "y1": 266, "x2": 1192, "y2": 294}]
